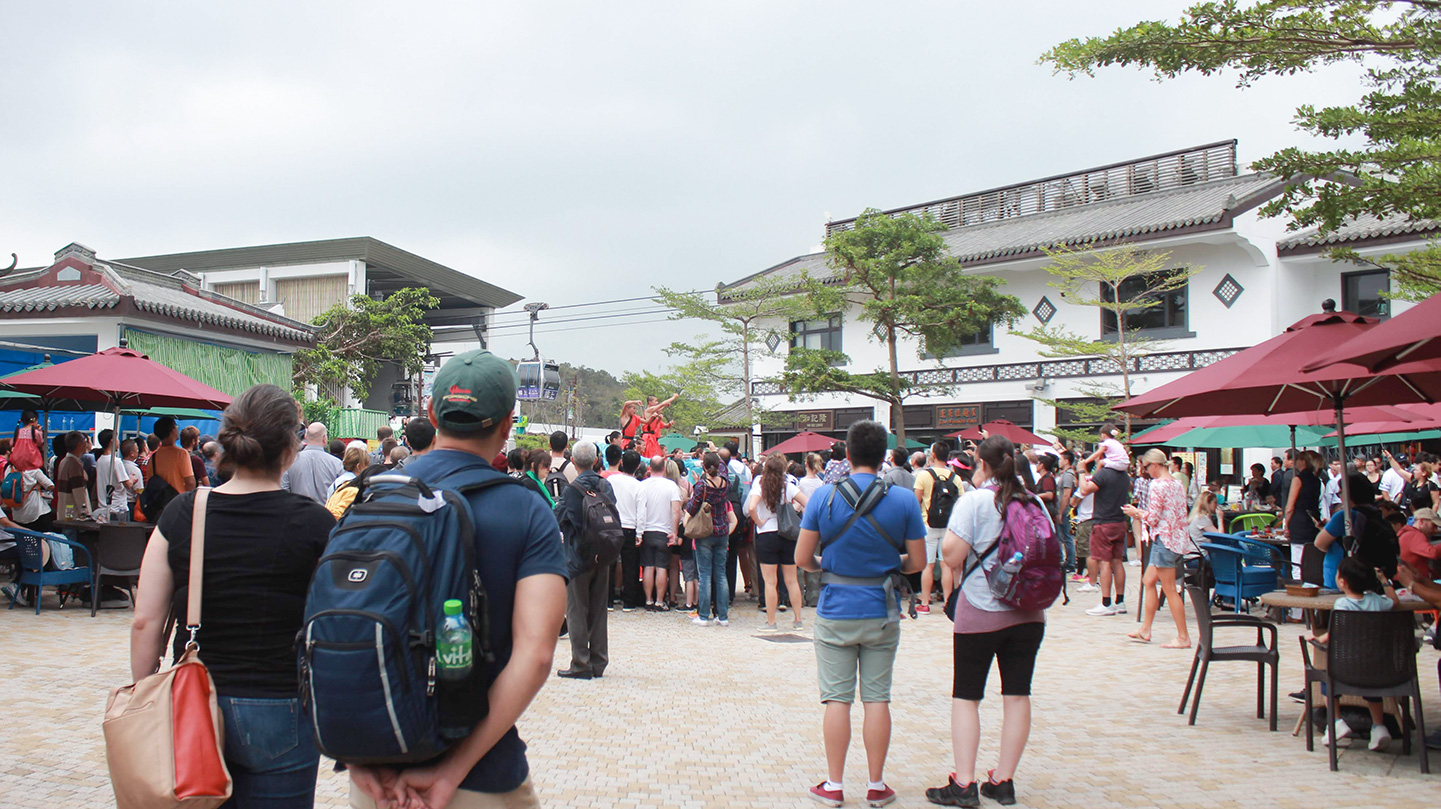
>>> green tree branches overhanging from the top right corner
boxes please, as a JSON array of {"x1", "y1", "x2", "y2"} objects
[{"x1": 1040, "y1": 0, "x2": 1441, "y2": 300}]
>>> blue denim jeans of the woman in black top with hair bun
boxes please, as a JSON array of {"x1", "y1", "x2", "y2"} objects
[{"x1": 219, "y1": 694, "x2": 320, "y2": 809}]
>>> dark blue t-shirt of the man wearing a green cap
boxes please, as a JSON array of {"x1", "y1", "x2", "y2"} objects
[{"x1": 405, "y1": 450, "x2": 566, "y2": 793}]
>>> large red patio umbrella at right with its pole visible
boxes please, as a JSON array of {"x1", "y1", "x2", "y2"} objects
[{"x1": 1117, "y1": 311, "x2": 1441, "y2": 532}]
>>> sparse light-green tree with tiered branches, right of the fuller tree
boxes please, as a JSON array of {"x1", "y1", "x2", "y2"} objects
[{"x1": 1019, "y1": 247, "x2": 1200, "y2": 443}]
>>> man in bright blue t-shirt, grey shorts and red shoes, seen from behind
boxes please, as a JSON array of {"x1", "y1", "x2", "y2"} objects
[{"x1": 795, "y1": 421, "x2": 925, "y2": 806}]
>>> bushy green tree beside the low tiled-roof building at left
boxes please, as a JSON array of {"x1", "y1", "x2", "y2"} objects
[{"x1": 293, "y1": 287, "x2": 440, "y2": 399}]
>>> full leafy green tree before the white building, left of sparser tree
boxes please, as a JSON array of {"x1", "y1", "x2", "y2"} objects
[{"x1": 784, "y1": 208, "x2": 1026, "y2": 441}]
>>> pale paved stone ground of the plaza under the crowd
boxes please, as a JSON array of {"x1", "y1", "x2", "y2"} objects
[{"x1": 0, "y1": 568, "x2": 1441, "y2": 809}]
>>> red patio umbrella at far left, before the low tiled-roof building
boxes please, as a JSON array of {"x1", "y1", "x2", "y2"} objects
[{"x1": 0, "y1": 348, "x2": 231, "y2": 412}]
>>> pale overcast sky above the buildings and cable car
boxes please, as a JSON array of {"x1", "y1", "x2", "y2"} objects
[{"x1": 0, "y1": 0, "x2": 1359, "y2": 375}]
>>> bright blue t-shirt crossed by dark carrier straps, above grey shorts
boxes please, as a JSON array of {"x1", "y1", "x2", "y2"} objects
[{"x1": 801, "y1": 474, "x2": 925, "y2": 620}]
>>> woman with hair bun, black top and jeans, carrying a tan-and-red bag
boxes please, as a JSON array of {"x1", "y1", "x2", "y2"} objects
[{"x1": 130, "y1": 385, "x2": 336, "y2": 809}]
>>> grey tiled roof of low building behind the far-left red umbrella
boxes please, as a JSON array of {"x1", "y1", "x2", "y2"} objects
[{"x1": 0, "y1": 261, "x2": 316, "y2": 343}]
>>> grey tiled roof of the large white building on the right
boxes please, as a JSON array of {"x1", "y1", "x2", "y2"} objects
[{"x1": 722, "y1": 174, "x2": 1281, "y2": 290}]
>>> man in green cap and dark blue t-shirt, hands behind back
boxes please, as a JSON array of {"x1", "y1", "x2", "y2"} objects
[{"x1": 349, "y1": 350, "x2": 566, "y2": 809}]
